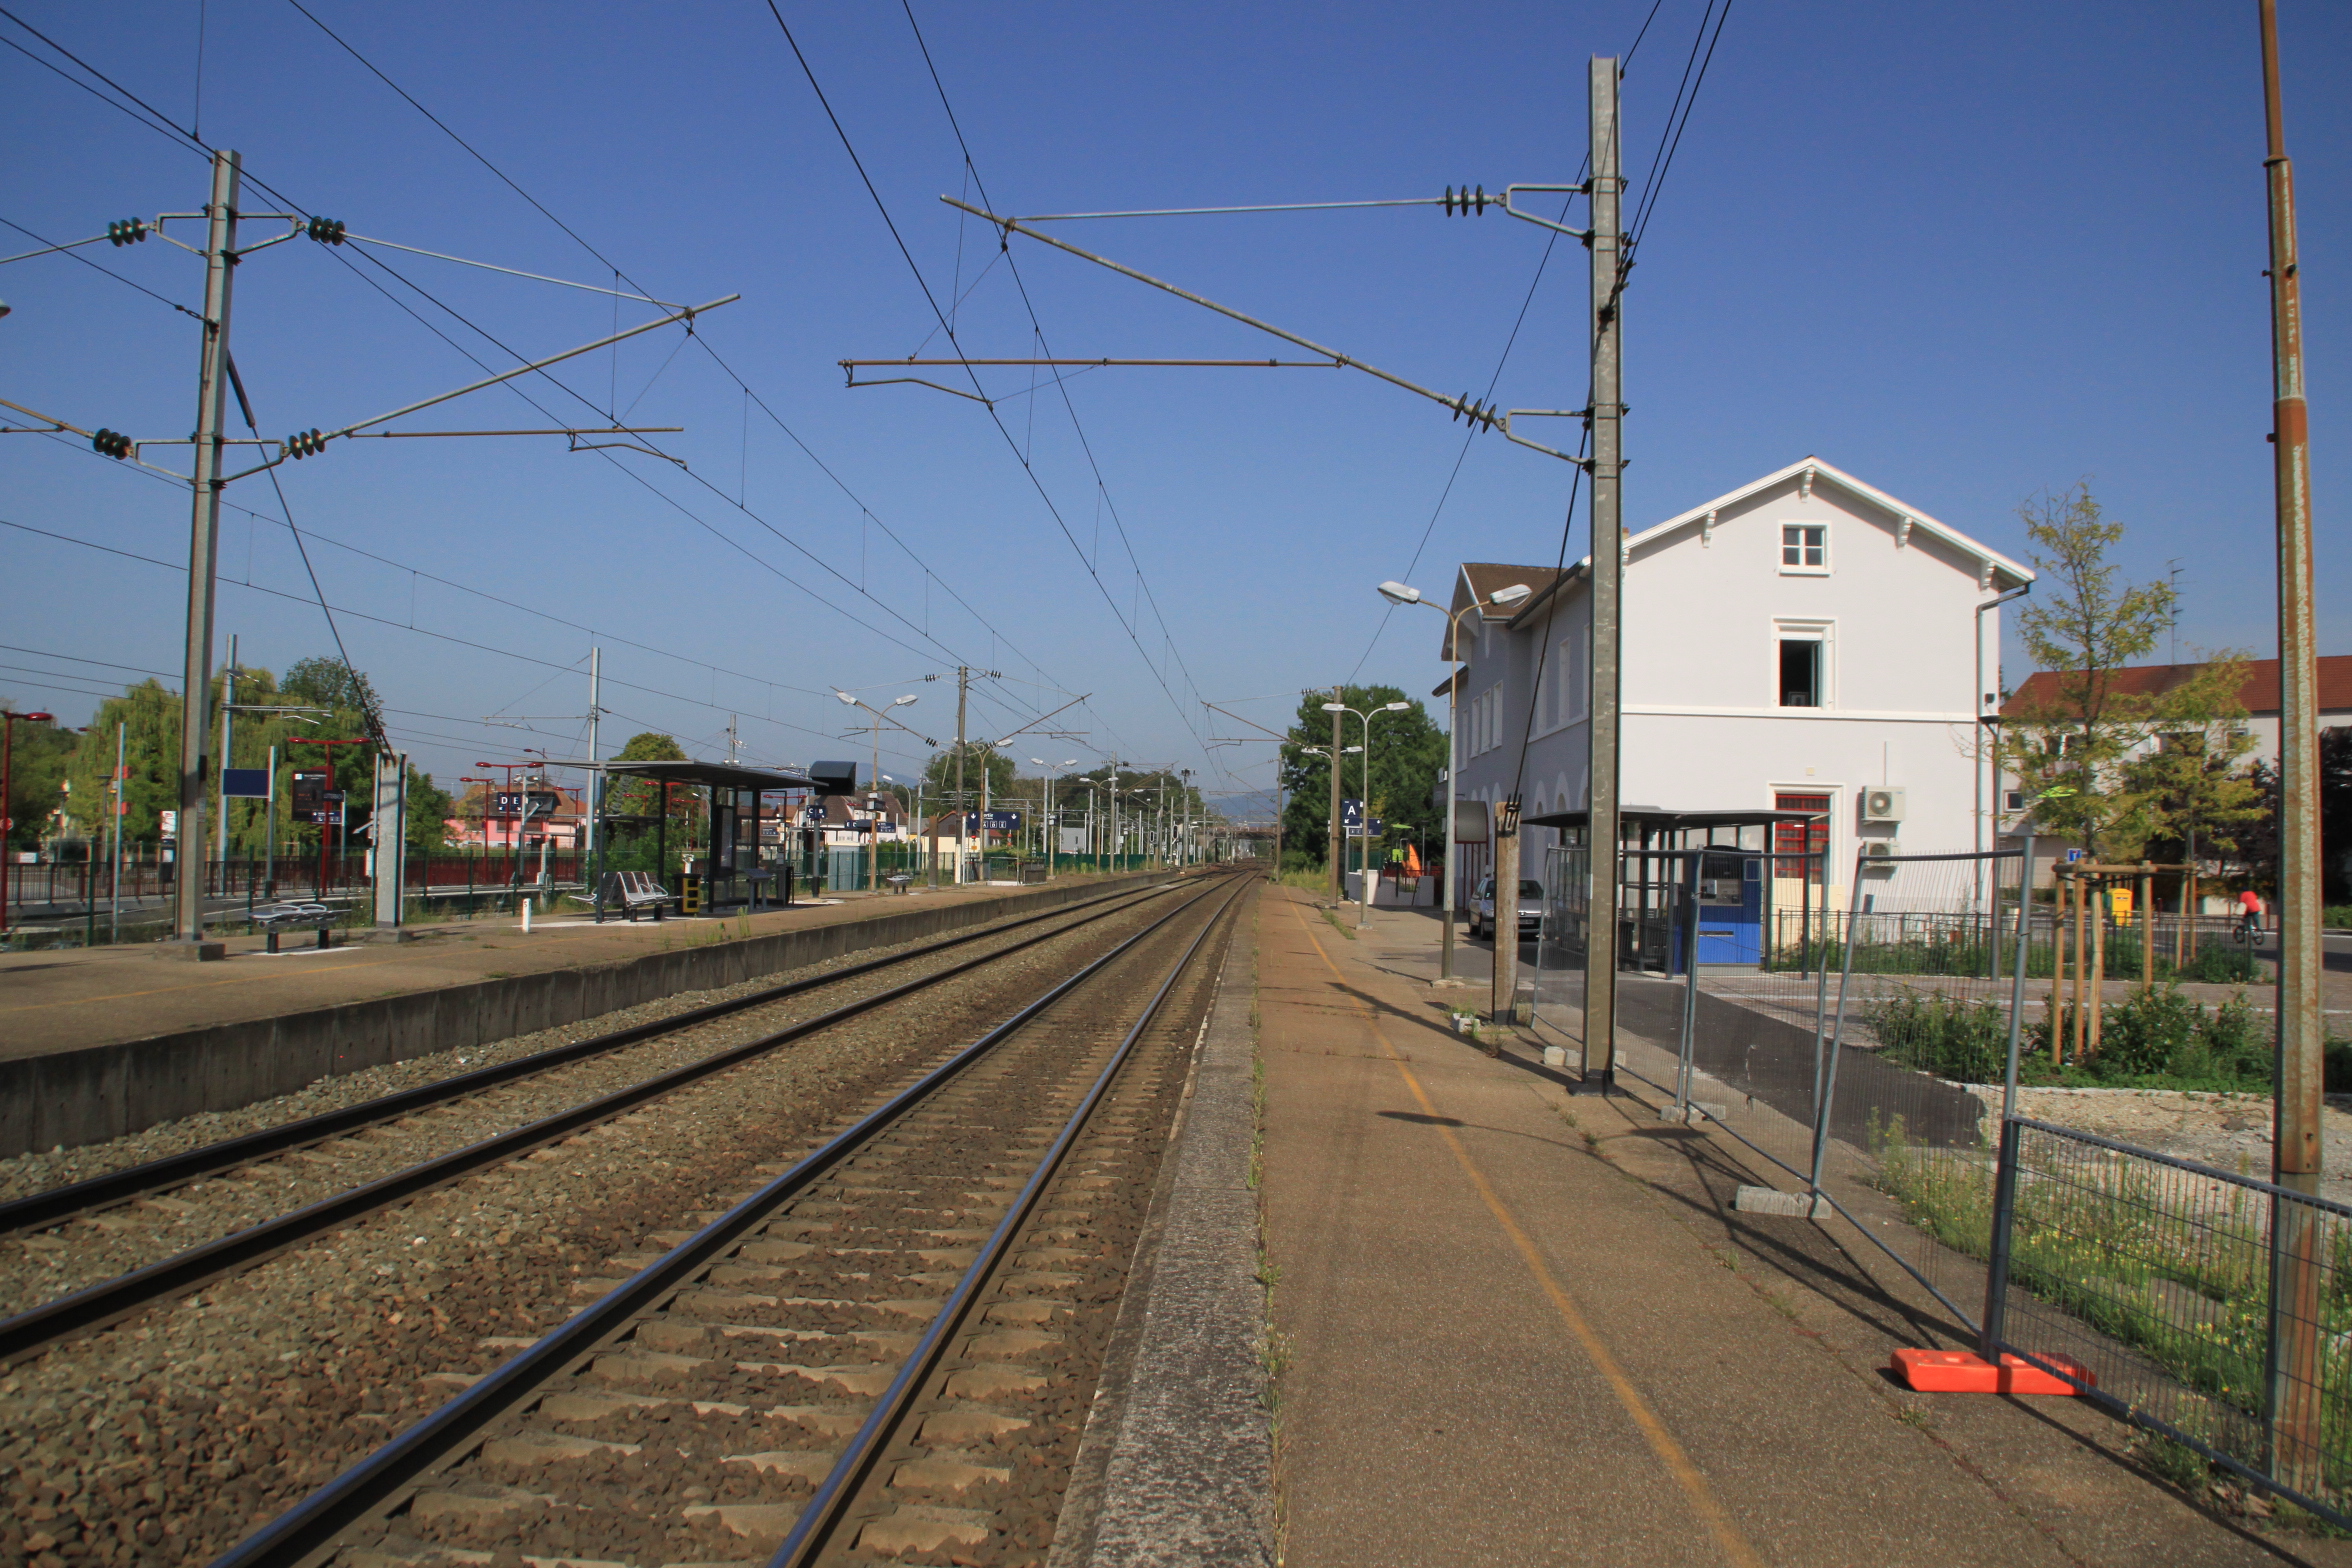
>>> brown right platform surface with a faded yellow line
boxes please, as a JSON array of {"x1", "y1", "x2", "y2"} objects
[{"x1": 1258, "y1": 889, "x2": 2352, "y2": 1568}]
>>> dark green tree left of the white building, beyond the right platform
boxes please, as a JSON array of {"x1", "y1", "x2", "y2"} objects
[{"x1": 1282, "y1": 686, "x2": 1446, "y2": 865}]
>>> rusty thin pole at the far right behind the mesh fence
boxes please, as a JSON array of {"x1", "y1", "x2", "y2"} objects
[{"x1": 2258, "y1": 0, "x2": 2326, "y2": 1490}]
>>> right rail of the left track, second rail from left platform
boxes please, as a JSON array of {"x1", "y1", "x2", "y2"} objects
[{"x1": 0, "y1": 879, "x2": 1190, "y2": 1366}]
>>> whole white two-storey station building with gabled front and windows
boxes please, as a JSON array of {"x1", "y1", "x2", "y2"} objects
[{"x1": 1437, "y1": 458, "x2": 2034, "y2": 898}]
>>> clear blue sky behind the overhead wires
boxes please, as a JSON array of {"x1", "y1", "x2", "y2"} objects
[{"x1": 0, "y1": 0, "x2": 2352, "y2": 808}]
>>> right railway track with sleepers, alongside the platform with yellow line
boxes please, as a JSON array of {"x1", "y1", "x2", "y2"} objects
[{"x1": 214, "y1": 877, "x2": 1251, "y2": 1568}]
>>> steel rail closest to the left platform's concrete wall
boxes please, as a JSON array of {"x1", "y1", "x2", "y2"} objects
[{"x1": 0, "y1": 884, "x2": 1171, "y2": 1234}]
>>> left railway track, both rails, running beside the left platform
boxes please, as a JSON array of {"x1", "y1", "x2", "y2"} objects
[{"x1": 0, "y1": 884, "x2": 1176, "y2": 1366}]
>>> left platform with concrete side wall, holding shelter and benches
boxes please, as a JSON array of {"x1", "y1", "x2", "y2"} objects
[{"x1": 0, "y1": 872, "x2": 1162, "y2": 1157}]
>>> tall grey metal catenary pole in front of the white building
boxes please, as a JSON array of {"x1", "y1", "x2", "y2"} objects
[{"x1": 1589, "y1": 54, "x2": 1625, "y2": 1093}]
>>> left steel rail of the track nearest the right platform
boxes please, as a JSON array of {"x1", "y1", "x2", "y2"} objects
[{"x1": 212, "y1": 869, "x2": 1251, "y2": 1568}]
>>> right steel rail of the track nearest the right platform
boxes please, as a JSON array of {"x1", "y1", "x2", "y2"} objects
[{"x1": 769, "y1": 884, "x2": 1247, "y2": 1568}]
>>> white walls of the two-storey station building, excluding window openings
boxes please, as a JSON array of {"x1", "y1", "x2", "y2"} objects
[{"x1": 1461, "y1": 477, "x2": 2009, "y2": 884}]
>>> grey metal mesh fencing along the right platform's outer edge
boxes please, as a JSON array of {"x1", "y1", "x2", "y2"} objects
[{"x1": 1536, "y1": 849, "x2": 2352, "y2": 1528}]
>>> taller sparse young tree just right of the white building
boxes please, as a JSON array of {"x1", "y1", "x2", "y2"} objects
[{"x1": 2002, "y1": 484, "x2": 2237, "y2": 858}]
